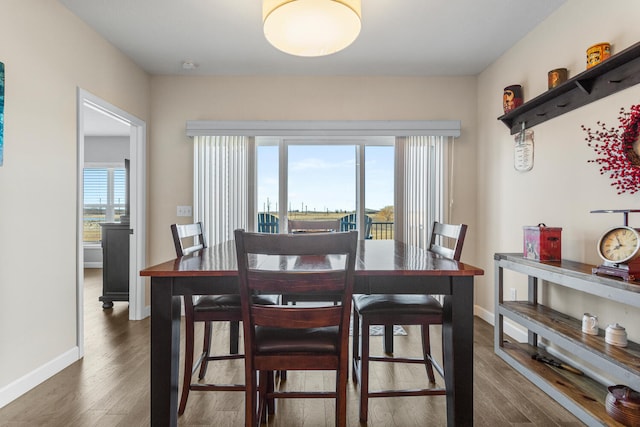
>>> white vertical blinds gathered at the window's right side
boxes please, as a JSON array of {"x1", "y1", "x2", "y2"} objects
[{"x1": 397, "y1": 136, "x2": 447, "y2": 248}]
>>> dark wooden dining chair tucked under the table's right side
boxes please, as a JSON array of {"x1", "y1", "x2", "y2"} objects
[{"x1": 352, "y1": 221, "x2": 467, "y2": 422}]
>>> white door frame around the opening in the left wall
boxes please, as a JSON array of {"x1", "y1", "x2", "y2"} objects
[{"x1": 76, "y1": 88, "x2": 150, "y2": 357}]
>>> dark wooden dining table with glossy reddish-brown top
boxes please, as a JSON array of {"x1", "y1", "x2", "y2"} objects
[{"x1": 140, "y1": 240, "x2": 484, "y2": 426}]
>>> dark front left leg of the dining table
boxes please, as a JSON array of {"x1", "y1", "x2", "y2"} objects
[{"x1": 150, "y1": 277, "x2": 180, "y2": 427}]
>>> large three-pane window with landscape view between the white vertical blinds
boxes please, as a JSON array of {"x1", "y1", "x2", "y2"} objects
[{"x1": 256, "y1": 138, "x2": 395, "y2": 239}]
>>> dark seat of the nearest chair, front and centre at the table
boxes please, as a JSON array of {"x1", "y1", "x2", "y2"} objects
[{"x1": 255, "y1": 326, "x2": 340, "y2": 353}]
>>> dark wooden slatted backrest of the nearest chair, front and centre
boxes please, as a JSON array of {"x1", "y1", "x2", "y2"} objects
[{"x1": 235, "y1": 230, "x2": 358, "y2": 357}]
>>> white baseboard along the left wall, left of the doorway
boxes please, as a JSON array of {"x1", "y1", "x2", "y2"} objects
[{"x1": 0, "y1": 347, "x2": 80, "y2": 408}]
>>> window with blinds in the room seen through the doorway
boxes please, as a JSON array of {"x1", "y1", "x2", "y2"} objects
[{"x1": 83, "y1": 167, "x2": 126, "y2": 243}]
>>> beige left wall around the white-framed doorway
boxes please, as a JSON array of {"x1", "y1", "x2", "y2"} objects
[{"x1": 0, "y1": 0, "x2": 149, "y2": 392}]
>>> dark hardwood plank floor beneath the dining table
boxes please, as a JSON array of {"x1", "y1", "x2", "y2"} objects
[{"x1": 0, "y1": 270, "x2": 583, "y2": 427}]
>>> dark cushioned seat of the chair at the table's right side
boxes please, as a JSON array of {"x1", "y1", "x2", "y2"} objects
[{"x1": 353, "y1": 294, "x2": 442, "y2": 315}]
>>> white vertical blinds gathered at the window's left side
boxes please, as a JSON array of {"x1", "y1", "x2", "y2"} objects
[{"x1": 193, "y1": 136, "x2": 249, "y2": 246}]
